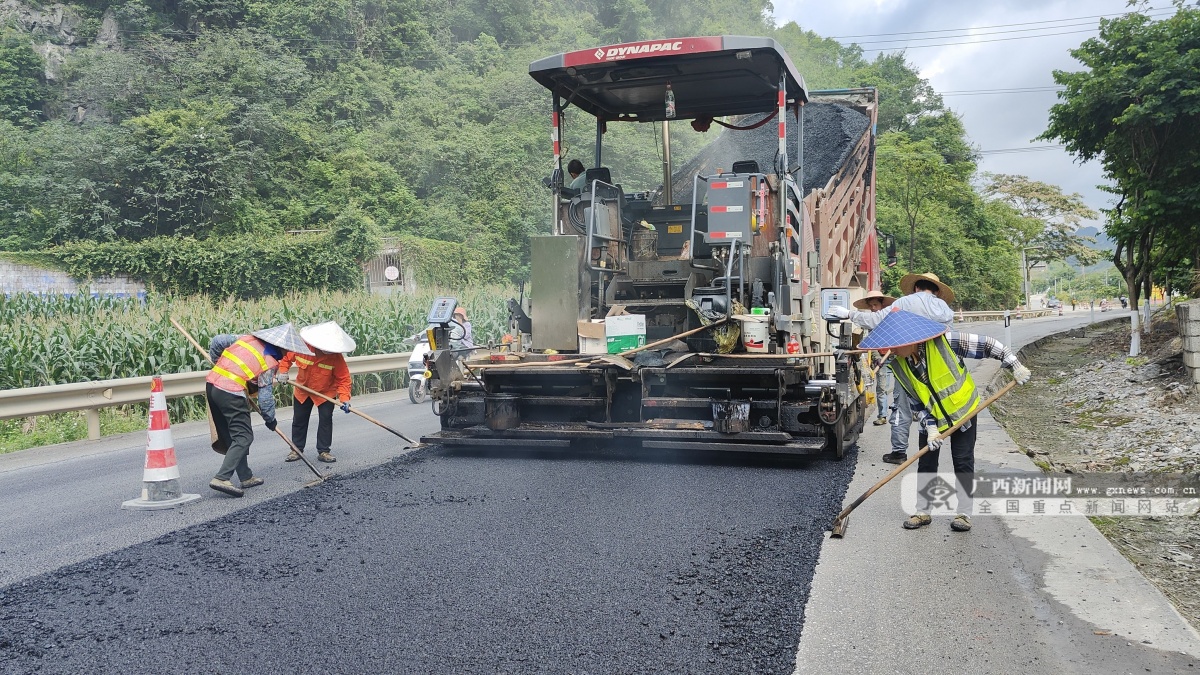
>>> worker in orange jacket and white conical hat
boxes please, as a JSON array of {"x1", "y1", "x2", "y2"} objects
[{"x1": 278, "y1": 321, "x2": 358, "y2": 462}]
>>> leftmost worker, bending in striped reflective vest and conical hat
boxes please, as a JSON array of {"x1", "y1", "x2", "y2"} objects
[{"x1": 204, "y1": 323, "x2": 312, "y2": 497}]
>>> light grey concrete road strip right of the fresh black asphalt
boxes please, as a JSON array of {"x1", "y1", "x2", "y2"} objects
[{"x1": 797, "y1": 312, "x2": 1200, "y2": 675}]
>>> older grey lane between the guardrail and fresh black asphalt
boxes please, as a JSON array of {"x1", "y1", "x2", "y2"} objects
[{"x1": 0, "y1": 392, "x2": 437, "y2": 586}]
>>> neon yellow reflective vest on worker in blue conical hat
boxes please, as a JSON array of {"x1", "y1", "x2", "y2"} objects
[{"x1": 893, "y1": 335, "x2": 980, "y2": 431}]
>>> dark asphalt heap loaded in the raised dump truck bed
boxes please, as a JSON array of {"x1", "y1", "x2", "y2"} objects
[{"x1": 671, "y1": 101, "x2": 870, "y2": 204}]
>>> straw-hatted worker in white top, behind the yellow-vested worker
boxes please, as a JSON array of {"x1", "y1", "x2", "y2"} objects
[{"x1": 829, "y1": 271, "x2": 954, "y2": 464}]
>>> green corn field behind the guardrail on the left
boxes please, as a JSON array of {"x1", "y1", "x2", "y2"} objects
[{"x1": 0, "y1": 286, "x2": 515, "y2": 420}]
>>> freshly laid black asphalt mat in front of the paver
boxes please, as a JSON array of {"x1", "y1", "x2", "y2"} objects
[{"x1": 0, "y1": 450, "x2": 854, "y2": 674}]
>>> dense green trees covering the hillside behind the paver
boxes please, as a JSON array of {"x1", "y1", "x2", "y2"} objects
[{"x1": 0, "y1": 0, "x2": 1022, "y2": 302}]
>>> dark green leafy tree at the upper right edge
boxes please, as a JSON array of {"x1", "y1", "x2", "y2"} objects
[{"x1": 1042, "y1": 2, "x2": 1200, "y2": 309}]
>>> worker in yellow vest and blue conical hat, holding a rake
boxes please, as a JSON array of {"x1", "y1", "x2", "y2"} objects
[{"x1": 858, "y1": 311, "x2": 1030, "y2": 532}]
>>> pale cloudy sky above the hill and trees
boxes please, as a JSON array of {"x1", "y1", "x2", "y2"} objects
[{"x1": 774, "y1": 0, "x2": 1171, "y2": 227}]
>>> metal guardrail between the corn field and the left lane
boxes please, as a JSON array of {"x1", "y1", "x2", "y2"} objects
[{"x1": 0, "y1": 352, "x2": 412, "y2": 440}]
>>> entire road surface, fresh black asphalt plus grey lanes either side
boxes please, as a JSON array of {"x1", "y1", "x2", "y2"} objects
[{"x1": 0, "y1": 306, "x2": 1196, "y2": 673}]
